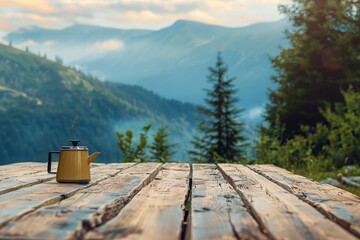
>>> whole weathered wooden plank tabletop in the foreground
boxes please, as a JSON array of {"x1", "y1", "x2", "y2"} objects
[{"x1": 0, "y1": 163, "x2": 360, "y2": 240}]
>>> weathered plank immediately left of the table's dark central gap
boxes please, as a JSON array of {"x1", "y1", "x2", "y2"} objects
[{"x1": 85, "y1": 164, "x2": 190, "y2": 240}]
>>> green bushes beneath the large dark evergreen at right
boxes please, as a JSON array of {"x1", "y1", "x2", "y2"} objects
[{"x1": 255, "y1": 88, "x2": 360, "y2": 173}]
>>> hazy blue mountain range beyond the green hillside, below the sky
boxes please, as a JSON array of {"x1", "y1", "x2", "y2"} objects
[{"x1": 5, "y1": 19, "x2": 288, "y2": 121}]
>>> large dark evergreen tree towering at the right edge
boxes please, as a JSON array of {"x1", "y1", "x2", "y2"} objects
[{"x1": 266, "y1": 0, "x2": 360, "y2": 140}]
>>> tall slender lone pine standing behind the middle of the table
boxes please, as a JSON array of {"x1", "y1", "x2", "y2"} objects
[{"x1": 189, "y1": 53, "x2": 245, "y2": 162}]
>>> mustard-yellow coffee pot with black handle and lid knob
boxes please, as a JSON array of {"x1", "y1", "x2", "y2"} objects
[{"x1": 48, "y1": 140, "x2": 100, "y2": 183}]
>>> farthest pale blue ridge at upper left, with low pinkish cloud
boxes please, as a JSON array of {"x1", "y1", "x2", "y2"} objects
[{"x1": 5, "y1": 24, "x2": 151, "y2": 62}]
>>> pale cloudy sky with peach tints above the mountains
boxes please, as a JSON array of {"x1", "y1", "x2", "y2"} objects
[{"x1": 0, "y1": 0, "x2": 286, "y2": 36}]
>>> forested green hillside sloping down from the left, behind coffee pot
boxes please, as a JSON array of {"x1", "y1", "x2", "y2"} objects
[{"x1": 0, "y1": 45, "x2": 195, "y2": 164}]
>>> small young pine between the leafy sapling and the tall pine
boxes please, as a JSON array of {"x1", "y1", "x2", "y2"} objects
[{"x1": 150, "y1": 127, "x2": 175, "y2": 163}]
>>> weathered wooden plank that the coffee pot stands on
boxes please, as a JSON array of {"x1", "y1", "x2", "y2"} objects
[{"x1": 0, "y1": 164, "x2": 133, "y2": 227}]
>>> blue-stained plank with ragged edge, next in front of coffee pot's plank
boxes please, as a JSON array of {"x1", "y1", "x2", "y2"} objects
[{"x1": 0, "y1": 163, "x2": 161, "y2": 239}]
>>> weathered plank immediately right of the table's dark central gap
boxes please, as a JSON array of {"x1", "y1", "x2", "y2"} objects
[{"x1": 188, "y1": 164, "x2": 267, "y2": 239}]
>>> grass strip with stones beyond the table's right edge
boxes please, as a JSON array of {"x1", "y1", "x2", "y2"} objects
[{"x1": 295, "y1": 166, "x2": 360, "y2": 196}]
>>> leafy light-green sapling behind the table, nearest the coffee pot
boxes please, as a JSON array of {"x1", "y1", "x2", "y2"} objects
[{"x1": 116, "y1": 124, "x2": 151, "y2": 162}]
